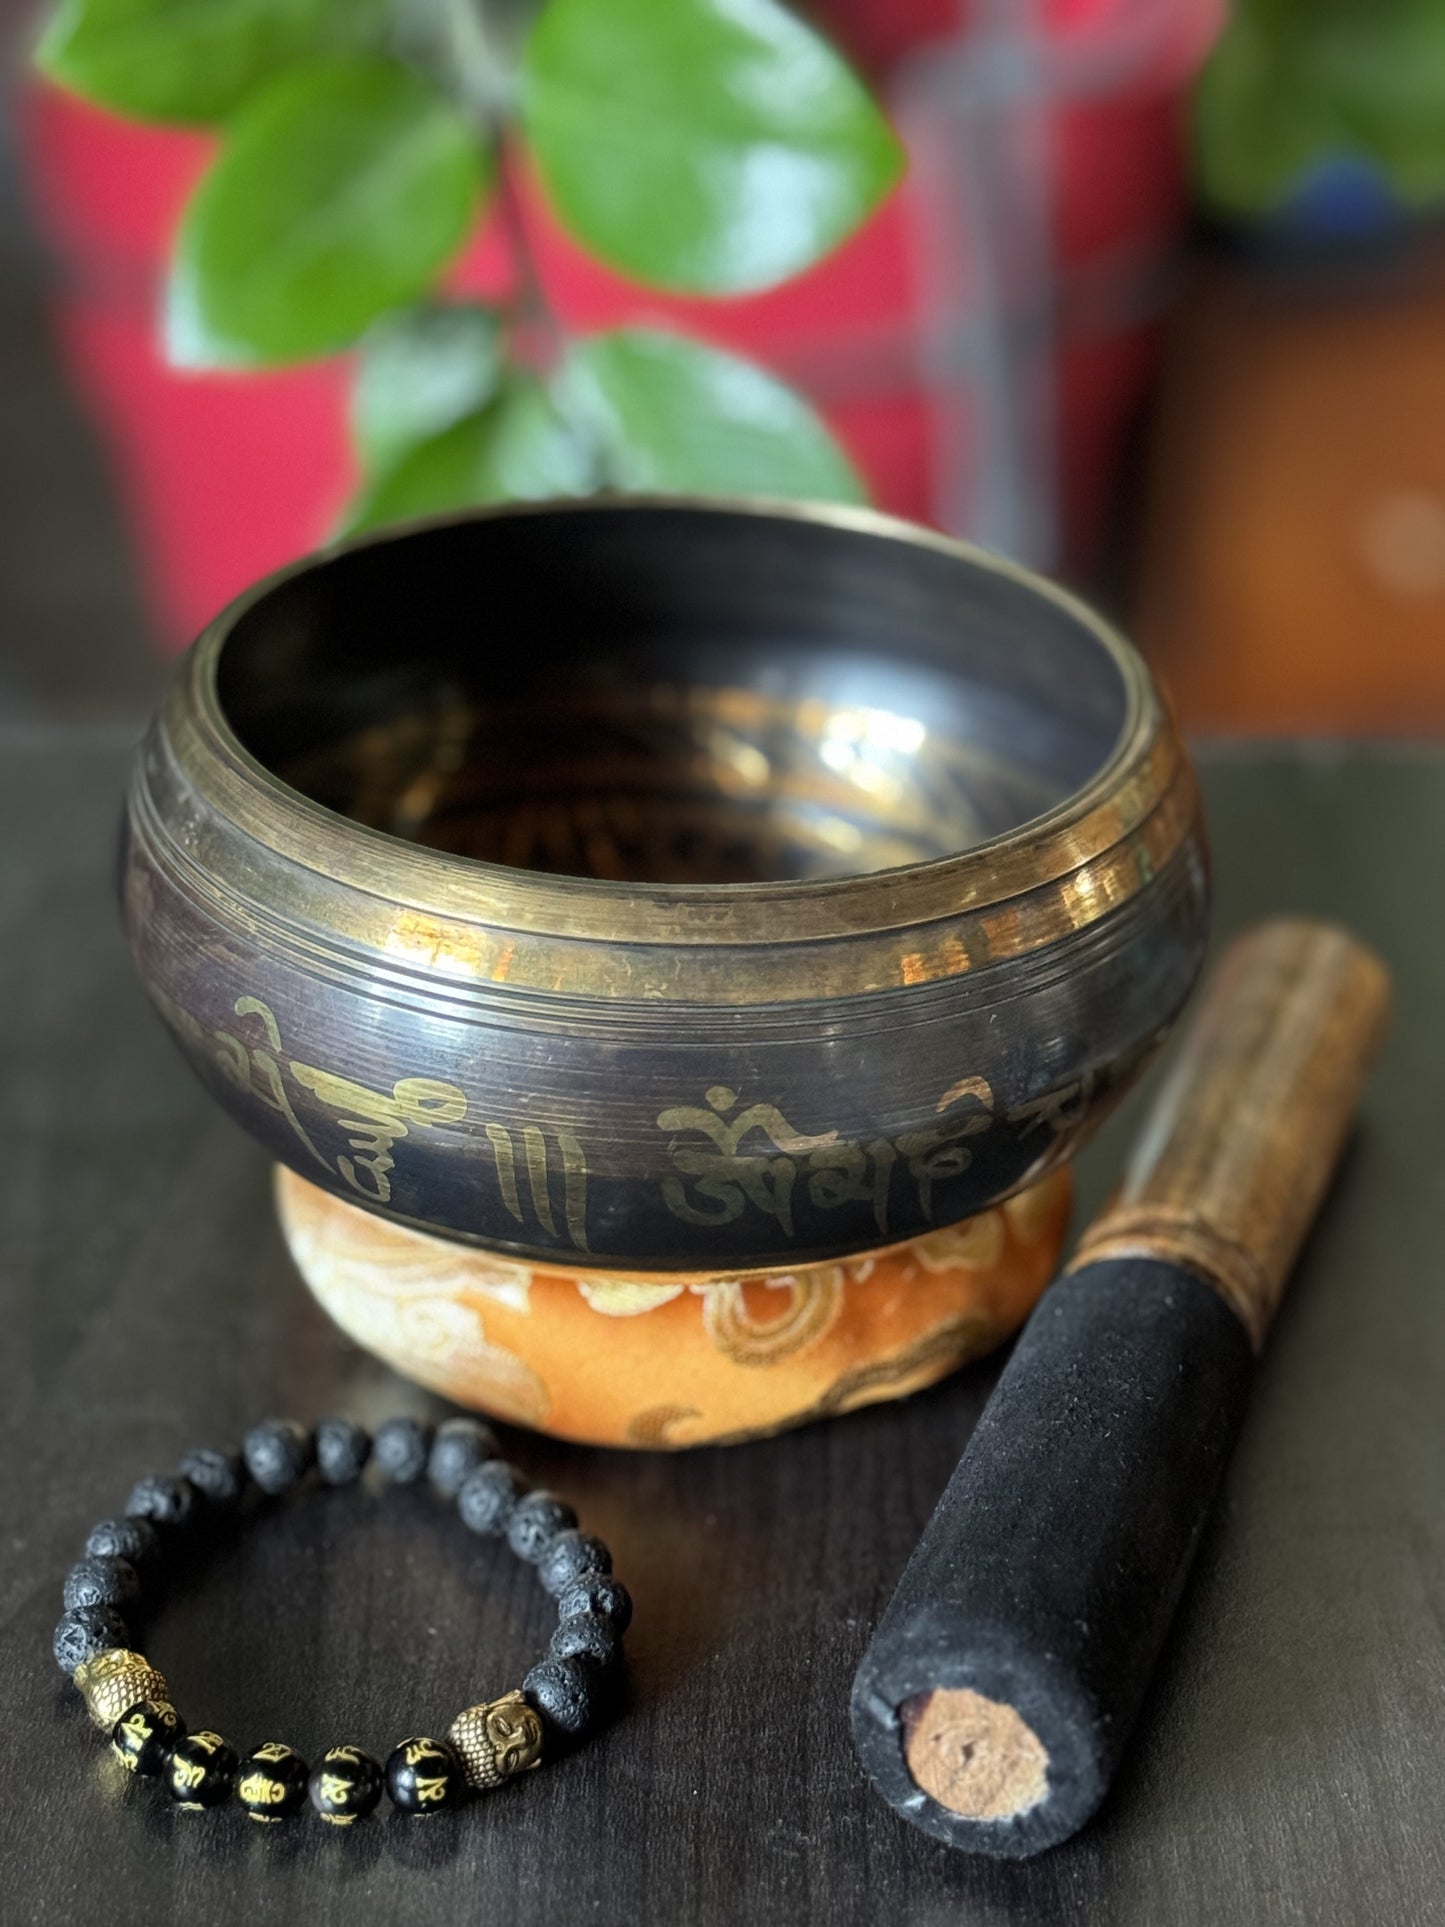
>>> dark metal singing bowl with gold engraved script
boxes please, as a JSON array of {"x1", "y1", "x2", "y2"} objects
[{"x1": 123, "y1": 497, "x2": 1208, "y2": 1278}]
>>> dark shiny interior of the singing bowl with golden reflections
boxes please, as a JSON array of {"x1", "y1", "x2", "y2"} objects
[{"x1": 216, "y1": 503, "x2": 1129, "y2": 884}]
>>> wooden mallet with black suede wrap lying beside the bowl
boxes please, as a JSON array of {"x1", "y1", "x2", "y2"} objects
[{"x1": 852, "y1": 921, "x2": 1389, "y2": 1856}]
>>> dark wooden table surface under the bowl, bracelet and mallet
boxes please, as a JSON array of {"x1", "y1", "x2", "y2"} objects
[{"x1": 0, "y1": 728, "x2": 1445, "y2": 1927}]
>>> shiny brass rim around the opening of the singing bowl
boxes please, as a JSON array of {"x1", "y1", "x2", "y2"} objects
[{"x1": 170, "y1": 493, "x2": 1191, "y2": 948}]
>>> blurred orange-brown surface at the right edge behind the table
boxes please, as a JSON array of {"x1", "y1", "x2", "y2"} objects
[{"x1": 1135, "y1": 251, "x2": 1445, "y2": 736}]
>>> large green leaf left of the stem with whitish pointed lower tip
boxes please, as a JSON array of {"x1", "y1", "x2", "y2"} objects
[{"x1": 166, "y1": 60, "x2": 487, "y2": 368}]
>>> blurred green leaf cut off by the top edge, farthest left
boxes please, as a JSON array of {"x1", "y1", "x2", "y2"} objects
[{"x1": 35, "y1": 0, "x2": 385, "y2": 123}]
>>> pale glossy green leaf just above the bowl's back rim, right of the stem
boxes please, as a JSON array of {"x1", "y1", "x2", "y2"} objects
[{"x1": 561, "y1": 328, "x2": 867, "y2": 501}]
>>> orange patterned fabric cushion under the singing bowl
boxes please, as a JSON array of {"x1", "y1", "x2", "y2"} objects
[{"x1": 276, "y1": 1170, "x2": 1071, "y2": 1449}]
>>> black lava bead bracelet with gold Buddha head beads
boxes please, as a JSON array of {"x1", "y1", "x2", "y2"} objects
[{"x1": 54, "y1": 1418, "x2": 632, "y2": 1827}]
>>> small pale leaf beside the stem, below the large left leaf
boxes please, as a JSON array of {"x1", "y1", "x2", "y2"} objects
[{"x1": 351, "y1": 303, "x2": 501, "y2": 472}]
